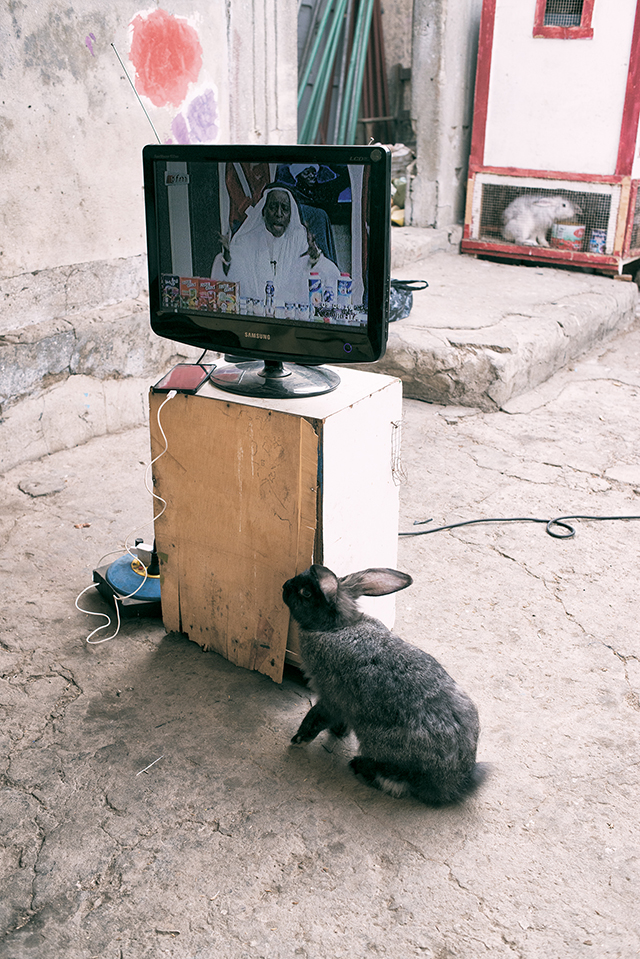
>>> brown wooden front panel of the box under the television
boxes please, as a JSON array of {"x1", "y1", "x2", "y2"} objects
[{"x1": 150, "y1": 394, "x2": 318, "y2": 682}]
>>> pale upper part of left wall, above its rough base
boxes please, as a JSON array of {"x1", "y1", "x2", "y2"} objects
[{"x1": 0, "y1": 0, "x2": 296, "y2": 277}]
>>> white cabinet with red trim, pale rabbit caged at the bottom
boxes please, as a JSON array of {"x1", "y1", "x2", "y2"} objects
[{"x1": 462, "y1": 0, "x2": 640, "y2": 274}]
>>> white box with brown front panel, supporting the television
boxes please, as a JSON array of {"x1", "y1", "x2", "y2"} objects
[{"x1": 150, "y1": 368, "x2": 402, "y2": 682}]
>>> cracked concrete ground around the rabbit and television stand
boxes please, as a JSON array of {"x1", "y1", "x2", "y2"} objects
[{"x1": 0, "y1": 316, "x2": 640, "y2": 959}]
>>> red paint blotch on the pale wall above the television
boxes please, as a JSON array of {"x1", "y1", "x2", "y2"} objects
[{"x1": 129, "y1": 10, "x2": 202, "y2": 107}]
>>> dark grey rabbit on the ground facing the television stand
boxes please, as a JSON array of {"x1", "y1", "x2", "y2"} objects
[{"x1": 282, "y1": 565, "x2": 487, "y2": 806}]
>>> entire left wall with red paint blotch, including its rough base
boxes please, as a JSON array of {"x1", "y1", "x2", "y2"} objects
[{"x1": 0, "y1": 0, "x2": 297, "y2": 470}]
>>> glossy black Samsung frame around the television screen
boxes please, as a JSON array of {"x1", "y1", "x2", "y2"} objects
[{"x1": 143, "y1": 144, "x2": 391, "y2": 366}]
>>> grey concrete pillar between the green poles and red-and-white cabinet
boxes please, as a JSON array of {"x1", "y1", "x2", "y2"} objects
[{"x1": 405, "y1": 0, "x2": 482, "y2": 229}]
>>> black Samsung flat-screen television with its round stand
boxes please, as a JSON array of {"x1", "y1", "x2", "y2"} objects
[{"x1": 143, "y1": 145, "x2": 391, "y2": 397}]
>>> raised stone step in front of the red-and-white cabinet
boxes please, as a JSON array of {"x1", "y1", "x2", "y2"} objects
[{"x1": 352, "y1": 251, "x2": 638, "y2": 410}]
